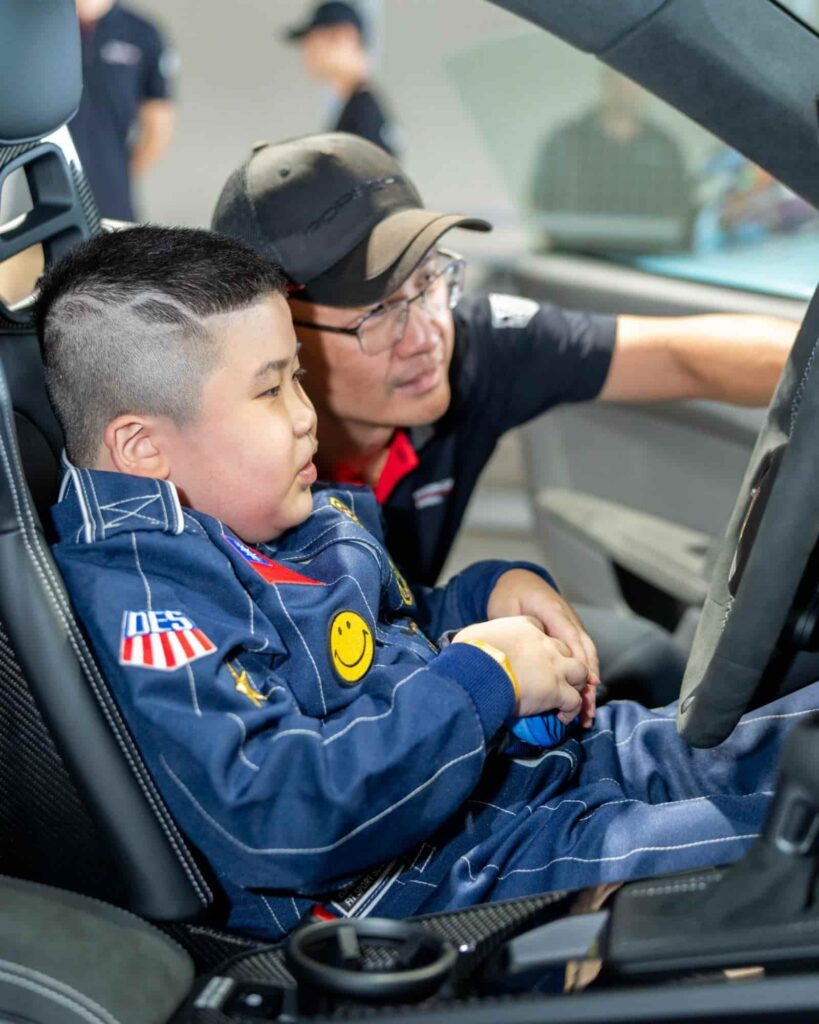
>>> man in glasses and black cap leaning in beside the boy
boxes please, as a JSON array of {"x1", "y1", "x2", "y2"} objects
[{"x1": 212, "y1": 133, "x2": 798, "y2": 706}]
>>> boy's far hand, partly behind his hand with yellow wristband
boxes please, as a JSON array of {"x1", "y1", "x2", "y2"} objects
[{"x1": 486, "y1": 569, "x2": 600, "y2": 682}]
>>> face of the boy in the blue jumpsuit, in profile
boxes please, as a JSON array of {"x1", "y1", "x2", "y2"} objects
[{"x1": 161, "y1": 295, "x2": 317, "y2": 544}]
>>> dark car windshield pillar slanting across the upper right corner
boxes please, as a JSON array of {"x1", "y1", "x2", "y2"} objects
[{"x1": 490, "y1": 0, "x2": 819, "y2": 207}]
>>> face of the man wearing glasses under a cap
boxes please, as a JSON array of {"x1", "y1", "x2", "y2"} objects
[{"x1": 291, "y1": 259, "x2": 455, "y2": 428}]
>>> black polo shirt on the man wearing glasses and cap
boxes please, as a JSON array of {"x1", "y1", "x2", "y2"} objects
[{"x1": 370, "y1": 295, "x2": 615, "y2": 585}]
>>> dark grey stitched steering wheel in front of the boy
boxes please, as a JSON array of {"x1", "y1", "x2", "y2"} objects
[{"x1": 677, "y1": 290, "x2": 819, "y2": 746}]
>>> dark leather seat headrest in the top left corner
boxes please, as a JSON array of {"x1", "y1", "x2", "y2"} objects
[{"x1": 0, "y1": 0, "x2": 83, "y2": 145}]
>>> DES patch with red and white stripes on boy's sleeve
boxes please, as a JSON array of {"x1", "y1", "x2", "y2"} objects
[{"x1": 120, "y1": 611, "x2": 216, "y2": 672}]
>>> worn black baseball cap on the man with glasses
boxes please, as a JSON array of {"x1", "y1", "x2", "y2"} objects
[{"x1": 211, "y1": 132, "x2": 491, "y2": 306}]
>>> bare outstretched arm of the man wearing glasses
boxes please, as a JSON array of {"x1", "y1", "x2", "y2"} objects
[{"x1": 599, "y1": 313, "x2": 799, "y2": 406}]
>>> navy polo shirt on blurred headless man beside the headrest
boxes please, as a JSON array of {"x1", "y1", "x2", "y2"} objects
[{"x1": 69, "y1": 4, "x2": 173, "y2": 220}]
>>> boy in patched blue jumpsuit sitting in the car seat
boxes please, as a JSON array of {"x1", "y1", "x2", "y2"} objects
[{"x1": 37, "y1": 227, "x2": 819, "y2": 938}]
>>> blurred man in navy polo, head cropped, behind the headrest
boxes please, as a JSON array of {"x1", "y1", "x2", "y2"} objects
[{"x1": 70, "y1": 0, "x2": 175, "y2": 220}]
